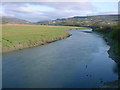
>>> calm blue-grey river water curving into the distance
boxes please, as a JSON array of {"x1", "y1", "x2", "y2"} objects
[{"x1": 2, "y1": 29, "x2": 118, "y2": 88}]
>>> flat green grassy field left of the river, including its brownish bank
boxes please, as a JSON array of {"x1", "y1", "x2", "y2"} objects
[{"x1": 2, "y1": 25, "x2": 83, "y2": 52}]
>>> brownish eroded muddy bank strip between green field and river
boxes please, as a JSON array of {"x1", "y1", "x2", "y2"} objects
[{"x1": 0, "y1": 33, "x2": 71, "y2": 53}]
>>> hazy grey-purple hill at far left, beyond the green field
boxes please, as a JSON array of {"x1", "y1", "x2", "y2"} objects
[{"x1": 2, "y1": 16, "x2": 31, "y2": 24}]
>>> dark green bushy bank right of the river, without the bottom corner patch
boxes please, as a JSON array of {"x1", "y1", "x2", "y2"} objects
[{"x1": 92, "y1": 26, "x2": 120, "y2": 63}]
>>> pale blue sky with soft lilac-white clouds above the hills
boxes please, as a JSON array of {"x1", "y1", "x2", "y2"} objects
[{"x1": 0, "y1": 0, "x2": 118, "y2": 22}]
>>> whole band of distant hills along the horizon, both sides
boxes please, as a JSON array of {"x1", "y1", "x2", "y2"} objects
[{"x1": 2, "y1": 14, "x2": 118, "y2": 26}]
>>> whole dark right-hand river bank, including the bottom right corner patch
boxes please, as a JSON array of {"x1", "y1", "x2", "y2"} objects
[{"x1": 92, "y1": 26, "x2": 120, "y2": 88}]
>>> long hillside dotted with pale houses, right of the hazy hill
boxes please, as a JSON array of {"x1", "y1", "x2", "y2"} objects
[{"x1": 37, "y1": 15, "x2": 118, "y2": 26}]
